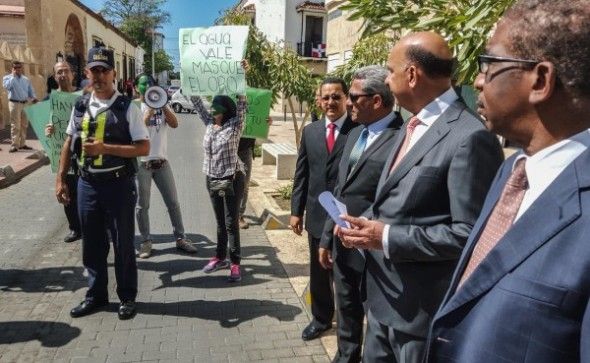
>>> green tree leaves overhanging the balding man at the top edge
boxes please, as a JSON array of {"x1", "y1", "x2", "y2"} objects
[{"x1": 341, "y1": 0, "x2": 514, "y2": 83}]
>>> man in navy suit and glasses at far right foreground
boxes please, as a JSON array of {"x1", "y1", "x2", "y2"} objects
[{"x1": 427, "y1": 0, "x2": 590, "y2": 363}]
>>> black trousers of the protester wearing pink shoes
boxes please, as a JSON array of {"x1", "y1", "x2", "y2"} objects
[{"x1": 210, "y1": 172, "x2": 244, "y2": 265}]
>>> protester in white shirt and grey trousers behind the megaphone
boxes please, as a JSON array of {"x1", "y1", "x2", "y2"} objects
[{"x1": 135, "y1": 74, "x2": 197, "y2": 258}]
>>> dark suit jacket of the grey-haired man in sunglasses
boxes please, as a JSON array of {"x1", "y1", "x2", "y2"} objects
[{"x1": 320, "y1": 113, "x2": 403, "y2": 273}]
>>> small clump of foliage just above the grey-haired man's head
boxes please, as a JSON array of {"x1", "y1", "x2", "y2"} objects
[{"x1": 332, "y1": 33, "x2": 393, "y2": 84}]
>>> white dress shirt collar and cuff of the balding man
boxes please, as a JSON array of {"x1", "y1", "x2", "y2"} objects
[{"x1": 381, "y1": 88, "x2": 459, "y2": 258}]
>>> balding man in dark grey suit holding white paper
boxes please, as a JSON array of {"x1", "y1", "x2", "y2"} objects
[{"x1": 336, "y1": 32, "x2": 503, "y2": 362}]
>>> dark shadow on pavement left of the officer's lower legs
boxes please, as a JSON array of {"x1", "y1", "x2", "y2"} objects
[{"x1": 0, "y1": 266, "x2": 86, "y2": 293}]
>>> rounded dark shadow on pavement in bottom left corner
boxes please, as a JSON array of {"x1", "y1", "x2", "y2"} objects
[{"x1": 0, "y1": 321, "x2": 81, "y2": 347}]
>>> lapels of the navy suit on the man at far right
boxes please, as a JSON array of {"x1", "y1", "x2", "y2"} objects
[{"x1": 440, "y1": 150, "x2": 590, "y2": 316}]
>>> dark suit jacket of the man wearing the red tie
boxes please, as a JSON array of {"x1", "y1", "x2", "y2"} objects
[{"x1": 291, "y1": 116, "x2": 355, "y2": 238}]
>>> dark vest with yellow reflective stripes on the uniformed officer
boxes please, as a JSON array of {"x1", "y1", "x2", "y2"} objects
[{"x1": 72, "y1": 94, "x2": 136, "y2": 172}]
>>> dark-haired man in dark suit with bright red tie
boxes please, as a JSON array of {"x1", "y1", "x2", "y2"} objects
[{"x1": 289, "y1": 78, "x2": 354, "y2": 340}]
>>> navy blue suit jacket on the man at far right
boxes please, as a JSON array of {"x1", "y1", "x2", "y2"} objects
[{"x1": 427, "y1": 150, "x2": 590, "y2": 363}]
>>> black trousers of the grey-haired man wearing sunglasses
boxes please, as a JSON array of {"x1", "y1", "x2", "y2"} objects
[{"x1": 333, "y1": 247, "x2": 365, "y2": 363}]
